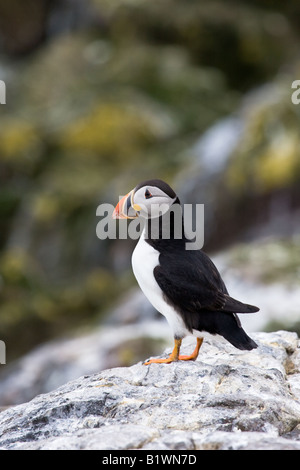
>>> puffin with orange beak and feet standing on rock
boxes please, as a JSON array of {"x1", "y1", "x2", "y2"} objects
[{"x1": 112, "y1": 179, "x2": 259, "y2": 365}]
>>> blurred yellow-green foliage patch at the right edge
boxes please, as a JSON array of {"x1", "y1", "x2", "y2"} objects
[{"x1": 228, "y1": 80, "x2": 300, "y2": 193}]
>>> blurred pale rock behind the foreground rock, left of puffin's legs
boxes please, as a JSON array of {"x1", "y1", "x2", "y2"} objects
[{"x1": 0, "y1": 321, "x2": 171, "y2": 407}]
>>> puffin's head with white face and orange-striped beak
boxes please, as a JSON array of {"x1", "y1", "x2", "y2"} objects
[{"x1": 113, "y1": 180, "x2": 176, "y2": 219}]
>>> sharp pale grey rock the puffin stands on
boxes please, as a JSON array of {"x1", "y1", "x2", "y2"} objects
[{"x1": 0, "y1": 331, "x2": 300, "y2": 450}]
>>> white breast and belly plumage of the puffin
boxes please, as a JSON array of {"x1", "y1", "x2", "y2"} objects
[{"x1": 131, "y1": 231, "x2": 190, "y2": 337}]
